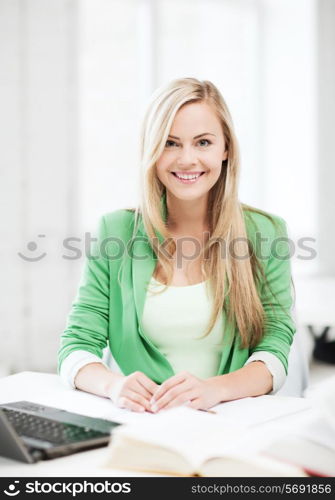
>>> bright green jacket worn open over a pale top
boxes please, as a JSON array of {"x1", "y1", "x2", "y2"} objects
[{"x1": 58, "y1": 196, "x2": 295, "y2": 384}]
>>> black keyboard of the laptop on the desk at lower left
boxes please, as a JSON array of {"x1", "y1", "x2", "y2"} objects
[{"x1": 1, "y1": 408, "x2": 109, "y2": 445}]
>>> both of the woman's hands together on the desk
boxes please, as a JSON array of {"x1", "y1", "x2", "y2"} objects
[{"x1": 109, "y1": 371, "x2": 220, "y2": 413}]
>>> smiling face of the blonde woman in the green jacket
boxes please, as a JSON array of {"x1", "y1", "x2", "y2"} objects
[{"x1": 156, "y1": 102, "x2": 228, "y2": 200}]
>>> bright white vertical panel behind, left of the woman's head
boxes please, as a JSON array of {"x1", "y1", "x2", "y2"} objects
[{"x1": 78, "y1": 0, "x2": 141, "y2": 230}]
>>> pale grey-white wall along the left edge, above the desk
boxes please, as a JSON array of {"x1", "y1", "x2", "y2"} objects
[{"x1": 0, "y1": 0, "x2": 78, "y2": 371}]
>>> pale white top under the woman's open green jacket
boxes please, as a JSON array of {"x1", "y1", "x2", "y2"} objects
[{"x1": 142, "y1": 277, "x2": 224, "y2": 378}]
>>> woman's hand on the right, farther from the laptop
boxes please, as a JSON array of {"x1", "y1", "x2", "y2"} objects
[{"x1": 151, "y1": 371, "x2": 220, "y2": 413}]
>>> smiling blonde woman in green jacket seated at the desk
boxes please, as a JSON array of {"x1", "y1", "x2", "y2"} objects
[{"x1": 58, "y1": 78, "x2": 295, "y2": 412}]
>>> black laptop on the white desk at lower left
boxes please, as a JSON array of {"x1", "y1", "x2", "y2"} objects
[{"x1": 0, "y1": 401, "x2": 121, "y2": 463}]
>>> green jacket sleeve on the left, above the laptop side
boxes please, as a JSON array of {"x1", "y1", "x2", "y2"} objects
[{"x1": 57, "y1": 216, "x2": 109, "y2": 373}]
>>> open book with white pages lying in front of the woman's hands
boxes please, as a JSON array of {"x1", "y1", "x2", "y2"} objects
[{"x1": 105, "y1": 407, "x2": 307, "y2": 477}]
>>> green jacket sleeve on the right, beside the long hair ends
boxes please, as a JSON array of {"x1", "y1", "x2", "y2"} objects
[{"x1": 250, "y1": 217, "x2": 296, "y2": 375}]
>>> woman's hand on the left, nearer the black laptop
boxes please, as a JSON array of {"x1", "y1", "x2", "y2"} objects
[{"x1": 108, "y1": 371, "x2": 159, "y2": 412}]
